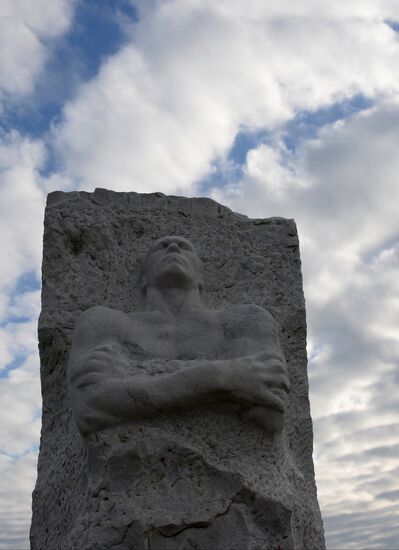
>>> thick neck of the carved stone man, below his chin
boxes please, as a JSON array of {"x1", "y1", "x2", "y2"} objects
[{"x1": 146, "y1": 287, "x2": 203, "y2": 316}]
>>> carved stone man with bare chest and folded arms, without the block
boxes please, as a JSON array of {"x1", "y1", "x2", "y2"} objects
[{"x1": 68, "y1": 236, "x2": 290, "y2": 435}]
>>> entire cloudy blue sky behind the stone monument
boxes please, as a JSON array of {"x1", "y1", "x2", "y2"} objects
[{"x1": 0, "y1": 0, "x2": 399, "y2": 550}]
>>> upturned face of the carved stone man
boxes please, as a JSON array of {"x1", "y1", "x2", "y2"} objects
[{"x1": 143, "y1": 236, "x2": 202, "y2": 296}]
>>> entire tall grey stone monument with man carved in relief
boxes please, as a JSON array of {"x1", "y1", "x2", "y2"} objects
[{"x1": 31, "y1": 189, "x2": 324, "y2": 550}]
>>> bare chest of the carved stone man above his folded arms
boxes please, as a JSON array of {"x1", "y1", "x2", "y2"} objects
[{"x1": 87, "y1": 305, "x2": 276, "y2": 361}]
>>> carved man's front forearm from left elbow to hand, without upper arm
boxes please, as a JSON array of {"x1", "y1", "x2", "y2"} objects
[{"x1": 71, "y1": 352, "x2": 289, "y2": 433}]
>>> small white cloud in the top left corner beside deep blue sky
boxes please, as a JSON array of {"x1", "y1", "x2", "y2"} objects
[{"x1": 0, "y1": 0, "x2": 74, "y2": 105}]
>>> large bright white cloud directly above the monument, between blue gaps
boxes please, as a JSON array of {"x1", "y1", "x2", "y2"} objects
[{"x1": 55, "y1": 0, "x2": 399, "y2": 193}]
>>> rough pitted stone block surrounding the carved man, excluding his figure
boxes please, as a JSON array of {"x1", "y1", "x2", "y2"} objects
[{"x1": 31, "y1": 189, "x2": 324, "y2": 550}]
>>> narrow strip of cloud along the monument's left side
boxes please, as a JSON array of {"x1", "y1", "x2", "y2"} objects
[{"x1": 0, "y1": 131, "x2": 45, "y2": 548}]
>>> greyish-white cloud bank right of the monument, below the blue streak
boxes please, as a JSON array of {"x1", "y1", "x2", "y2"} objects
[{"x1": 213, "y1": 101, "x2": 399, "y2": 548}]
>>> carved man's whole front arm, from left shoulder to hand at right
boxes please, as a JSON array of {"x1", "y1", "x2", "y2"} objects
[{"x1": 68, "y1": 306, "x2": 289, "y2": 434}]
